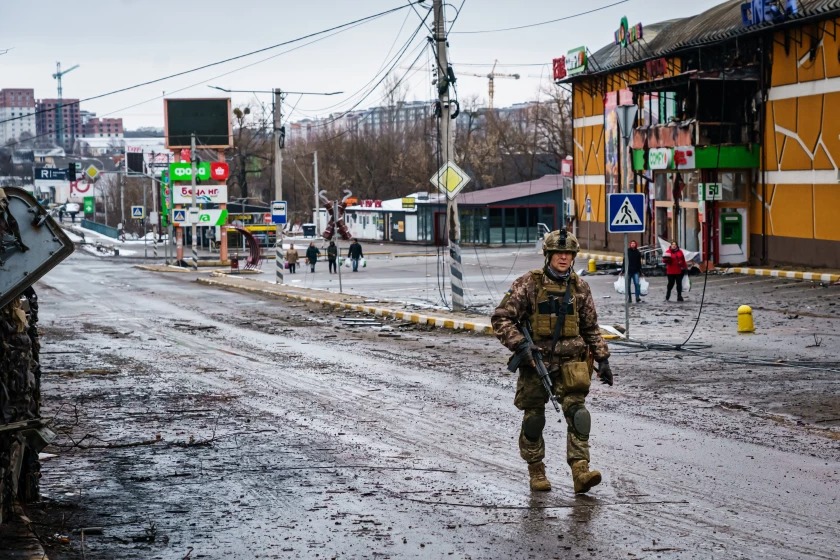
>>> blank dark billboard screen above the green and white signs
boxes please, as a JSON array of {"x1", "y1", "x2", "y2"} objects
[{"x1": 163, "y1": 97, "x2": 233, "y2": 150}]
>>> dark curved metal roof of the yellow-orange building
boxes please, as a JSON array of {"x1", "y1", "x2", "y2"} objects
[{"x1": 566, "y1": 0, "x2": 840, "y2": 77}]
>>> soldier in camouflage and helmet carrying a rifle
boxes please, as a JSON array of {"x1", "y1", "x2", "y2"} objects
[{"x1": 491, "y1": 230, "x2": 613, "y2": 493}]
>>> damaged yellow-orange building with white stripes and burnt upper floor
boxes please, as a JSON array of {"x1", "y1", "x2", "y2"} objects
[{"x1": 554, "y1": 0, "x2": 840, "y2": 268}]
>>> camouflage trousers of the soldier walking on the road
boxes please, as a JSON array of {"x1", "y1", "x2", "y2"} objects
[{"x1": 513, "y1": 366, "x2": 589, "y2": 465}]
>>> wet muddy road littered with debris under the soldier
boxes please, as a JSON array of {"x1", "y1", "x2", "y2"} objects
[{"x1": 27, "y1": 253, "x2": 840, "y2": 560}]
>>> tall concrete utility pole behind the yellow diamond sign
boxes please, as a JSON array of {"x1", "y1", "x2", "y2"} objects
[{"x1": 433, "y1": 0, "x2": 465, "y2": 311}]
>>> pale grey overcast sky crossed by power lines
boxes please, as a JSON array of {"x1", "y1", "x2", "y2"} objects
[{"x1": 0, "y1": 0, "x2": 722, "y2": 129}]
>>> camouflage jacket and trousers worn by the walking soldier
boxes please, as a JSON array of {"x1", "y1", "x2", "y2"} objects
[{"x1": 491, "y1": 253, "x2": 610, "y2": 465}]
